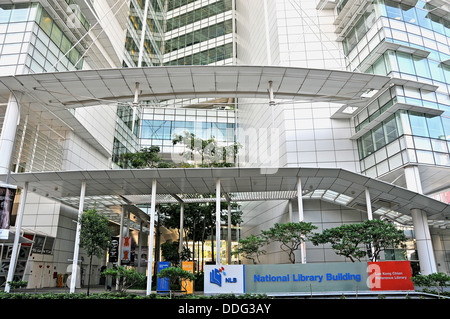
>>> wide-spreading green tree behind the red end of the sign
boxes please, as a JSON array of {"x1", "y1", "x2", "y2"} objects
[{"x1": 311, "y1": 219, "x2": 406, "y2": 262}]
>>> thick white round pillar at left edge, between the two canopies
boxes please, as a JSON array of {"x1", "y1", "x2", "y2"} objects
[{"x1": 0, "y1": 92, "x2": 22, "y2": 178}]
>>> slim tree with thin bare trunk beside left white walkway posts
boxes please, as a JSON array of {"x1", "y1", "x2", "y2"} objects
[{"x1": 79, "y1": 208, "x2": 111, "y2": 295}]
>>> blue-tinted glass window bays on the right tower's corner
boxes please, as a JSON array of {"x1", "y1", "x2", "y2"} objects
[{"x1": 343, "y1": 0, "x2": 450, "y2": 176}]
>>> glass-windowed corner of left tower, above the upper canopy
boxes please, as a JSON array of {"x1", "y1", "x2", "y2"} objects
[{"x1": 0, "y1": 3, "x2": 83, "y2": 74}]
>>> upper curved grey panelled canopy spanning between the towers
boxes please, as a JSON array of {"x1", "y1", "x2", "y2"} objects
[{"x1": 0, "y1": 65, "x2": 389, "y2": 109}]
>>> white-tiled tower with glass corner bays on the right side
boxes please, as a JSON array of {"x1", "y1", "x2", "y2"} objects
[{"x1": 236, "y1": 0, "x2": 450, "y2": 271}]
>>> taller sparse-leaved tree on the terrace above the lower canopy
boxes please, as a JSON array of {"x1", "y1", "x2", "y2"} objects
[{"x1": 172, "y1": 132, "x2": 242, "y2": 167}]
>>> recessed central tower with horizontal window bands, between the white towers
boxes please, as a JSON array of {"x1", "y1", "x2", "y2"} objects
[{"x1": 135, "y1": 0, "x2": 236, "y2": 164}]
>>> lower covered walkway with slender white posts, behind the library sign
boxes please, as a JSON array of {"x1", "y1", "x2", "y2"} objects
[{"x1": 0, "y1": 168, "x2": 450, "y2": 294}]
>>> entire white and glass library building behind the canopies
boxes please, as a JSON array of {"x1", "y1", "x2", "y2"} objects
[{"x1": 0, "y1": 0, "x2": 450, "y2": 287}]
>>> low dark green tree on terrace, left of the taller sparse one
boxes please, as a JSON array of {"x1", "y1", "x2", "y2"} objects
[{"x1": 122, "y1": 146, "x2": 174, "y2": 168}]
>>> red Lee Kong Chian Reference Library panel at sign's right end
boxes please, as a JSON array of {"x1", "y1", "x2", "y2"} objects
[{"x1": 369, "y1": 261, "x2": 414, "y2": 291}]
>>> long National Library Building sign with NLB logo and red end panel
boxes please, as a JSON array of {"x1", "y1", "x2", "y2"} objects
[{"x1": 205, "y1": 261, "x2": 414, "y2": 293}]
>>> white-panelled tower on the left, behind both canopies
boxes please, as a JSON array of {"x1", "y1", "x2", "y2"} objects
[{"x1": 0, "y1": 0, "x2": 128, "y2": 287}]
